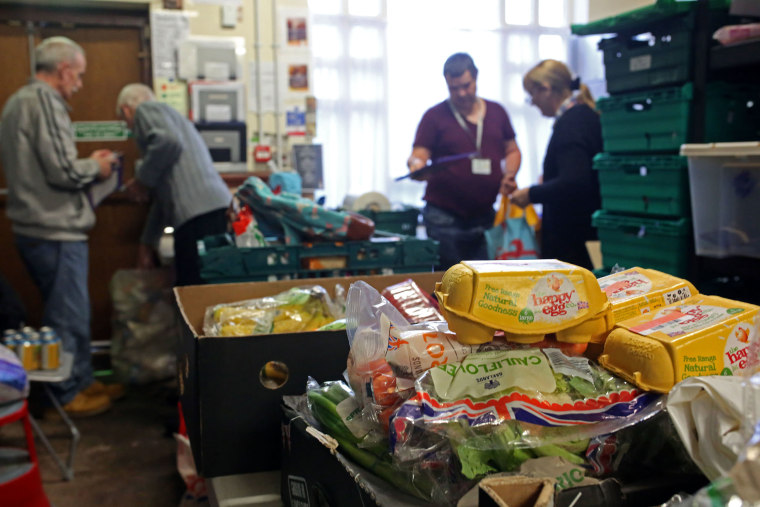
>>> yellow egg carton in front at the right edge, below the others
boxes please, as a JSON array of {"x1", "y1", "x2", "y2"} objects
[{"x1": 599, "y1": 295, "x2": 760, "y2": 393}]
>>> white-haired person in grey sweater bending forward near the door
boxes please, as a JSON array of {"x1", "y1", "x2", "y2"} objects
[{"x1": 116, "y1": 83, "x2": 232, "y2": 285}]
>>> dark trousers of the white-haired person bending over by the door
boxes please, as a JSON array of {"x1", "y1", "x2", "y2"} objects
[{"x1": 174, "y1": 208, "x2": 227, "y2": 286}]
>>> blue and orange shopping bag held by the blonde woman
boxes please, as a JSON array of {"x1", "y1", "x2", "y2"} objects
[{"x1": 486, "y1": 198, "x2": 541, "y2": 260}]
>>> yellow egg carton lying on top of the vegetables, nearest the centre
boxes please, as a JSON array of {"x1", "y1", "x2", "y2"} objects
[{"x1": 435, "y1": 259, "x2": 614, "y2": 344}]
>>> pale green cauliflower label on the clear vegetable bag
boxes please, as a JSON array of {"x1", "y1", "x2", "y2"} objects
[{"x1": 430, "y1": 349, "x2": 557, "y2": 400}]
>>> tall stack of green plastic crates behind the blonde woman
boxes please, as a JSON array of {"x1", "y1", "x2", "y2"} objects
[{"x1": 571, "y1": 0, "x2": 760, "y2": 278}]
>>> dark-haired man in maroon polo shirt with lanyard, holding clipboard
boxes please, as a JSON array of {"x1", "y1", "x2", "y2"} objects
[{"x1": 407, "y1": 53, "x2": 521, "y2": 270}]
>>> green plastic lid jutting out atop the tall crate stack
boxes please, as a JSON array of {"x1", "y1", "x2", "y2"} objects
[{"x1": 570, "y1": 0, "x2": 731, "y2": 35}]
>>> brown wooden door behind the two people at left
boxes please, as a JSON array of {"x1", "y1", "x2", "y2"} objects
[{"x1": 0, "y1": 6, "x2": 150, "y2": 346}]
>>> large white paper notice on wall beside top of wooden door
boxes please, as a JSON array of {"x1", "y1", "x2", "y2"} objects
[{"x1": 150, "y1": 10, "x2": 190, "y2": 79}]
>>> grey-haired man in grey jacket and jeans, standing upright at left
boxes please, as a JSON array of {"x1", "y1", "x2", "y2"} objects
[{"x1": 0, "y1": 37, "x2": 123, "y2": 416}]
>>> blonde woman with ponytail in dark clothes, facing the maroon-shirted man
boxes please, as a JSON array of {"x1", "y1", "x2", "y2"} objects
[{"x1": 511, "y1": 60, "x2": 602, "y2": 269}]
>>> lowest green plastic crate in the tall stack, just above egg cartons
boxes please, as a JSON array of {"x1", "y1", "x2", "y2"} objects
[{"x1": 592, "y1": 210, "x2": 694, "y2": 278}]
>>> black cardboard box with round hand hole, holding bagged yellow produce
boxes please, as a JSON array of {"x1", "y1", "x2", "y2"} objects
[{"x1": 174, "y1": 273, "x2": 442, "y2": 477}]
